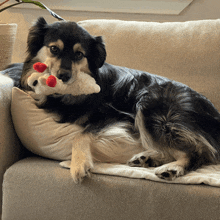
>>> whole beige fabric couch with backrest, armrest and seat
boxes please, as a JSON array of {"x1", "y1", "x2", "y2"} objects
[{"x1": 0, "y1": 20, "x2": 220, "y2": 220}]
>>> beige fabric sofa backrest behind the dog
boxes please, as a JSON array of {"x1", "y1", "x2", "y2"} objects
[{"x1": 79, "y1": 19, "x2": 220, "y2": 110}]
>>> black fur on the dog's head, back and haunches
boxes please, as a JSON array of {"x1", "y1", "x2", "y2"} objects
[{"x1": 6, "y1": 18, "x2": 220, "y2": 179}]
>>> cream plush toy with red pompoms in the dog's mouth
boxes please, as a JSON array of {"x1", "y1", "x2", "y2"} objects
[{"x1": 27, "y1": 63, "x2": 100, "y2": 96}]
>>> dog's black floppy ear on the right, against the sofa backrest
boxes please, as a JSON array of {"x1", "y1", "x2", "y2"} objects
[{"x1": 88, "y1": 36, "x2": 106, "y2": 70}]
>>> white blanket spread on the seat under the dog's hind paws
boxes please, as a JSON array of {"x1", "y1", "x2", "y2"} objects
[{"x1": 60, "y1": 161, "x2": 220, "y2": 187}]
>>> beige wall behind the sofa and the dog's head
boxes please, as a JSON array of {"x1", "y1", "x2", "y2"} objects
[{"x1": 0, "y1": 0, "x2": 220, "y2": 62}]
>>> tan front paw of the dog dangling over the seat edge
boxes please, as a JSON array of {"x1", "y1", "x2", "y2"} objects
[{"x1": 70, "y1": 161, "x2": 93, "y2": 183}]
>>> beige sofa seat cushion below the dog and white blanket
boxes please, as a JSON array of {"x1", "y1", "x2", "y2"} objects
[{"x1": 2, "y1": 157, "x2": 220, "y2": 220}]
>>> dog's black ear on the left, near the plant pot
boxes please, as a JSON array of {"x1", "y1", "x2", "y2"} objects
[{"x1": 27, "y1": 17, "x2": 48, "y2": 60}]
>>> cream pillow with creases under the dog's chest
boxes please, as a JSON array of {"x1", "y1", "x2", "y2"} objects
[{"x1": 11, "y1": 87, "x2": 84, "y2": 160}]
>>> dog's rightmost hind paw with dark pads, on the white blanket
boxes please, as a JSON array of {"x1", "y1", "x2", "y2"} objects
[{"x1": 155, "y1": 163, "x2": 185, "y2": 181}]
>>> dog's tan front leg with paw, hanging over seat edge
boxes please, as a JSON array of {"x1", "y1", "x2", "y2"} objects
[{"x1": 70, "y1": 134, "x2": 93, "y2": 183}]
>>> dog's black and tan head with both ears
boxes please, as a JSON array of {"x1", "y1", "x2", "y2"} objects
[{"x1": 21, "y1": 17, "x2": 106, "y2": 88}]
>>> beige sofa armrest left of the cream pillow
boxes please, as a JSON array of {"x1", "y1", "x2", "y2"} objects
[{"x1": 0, "y1": 72, "x2": 22, "y2": 211}]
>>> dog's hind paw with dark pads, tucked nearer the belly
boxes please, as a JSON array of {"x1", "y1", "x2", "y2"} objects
[{"x1": 127, "y1": 151, "x2": 162, "y2": 167}]
